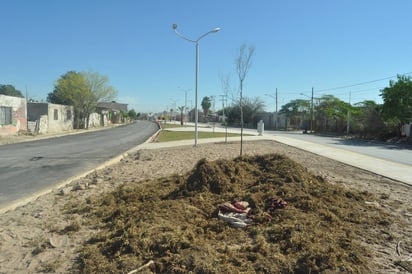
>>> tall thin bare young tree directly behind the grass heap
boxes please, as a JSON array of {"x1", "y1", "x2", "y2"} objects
[{"x1": 235, "y1": 44, "x2": 255, "y2": 156}]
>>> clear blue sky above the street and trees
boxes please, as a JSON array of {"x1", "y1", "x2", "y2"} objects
[{"x1": 0, "y1": 0, "x2": 412, "y2": 112}]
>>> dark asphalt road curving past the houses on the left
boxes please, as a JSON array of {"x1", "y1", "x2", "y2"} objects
[{"x1": 0, "y1": 121, "x2": 158, "y2": 209}]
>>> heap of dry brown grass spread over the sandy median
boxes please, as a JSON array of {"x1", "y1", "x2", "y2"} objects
[{"x1": 72, "y1": 154, "x2": 391, "y2": 273}]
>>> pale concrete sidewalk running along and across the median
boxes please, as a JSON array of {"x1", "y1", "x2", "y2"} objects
[{"x1": 137, "y1": 127, "x2": 412, "y2": 185}]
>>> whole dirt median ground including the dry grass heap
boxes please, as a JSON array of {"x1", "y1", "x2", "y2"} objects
[{"x1": 0, "y1": 141, "x2": 412, "y2": 273}]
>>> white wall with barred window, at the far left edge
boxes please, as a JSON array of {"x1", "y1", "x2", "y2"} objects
[{"x1": 0, "y1": 94, "x2": 27, "y2": 136}]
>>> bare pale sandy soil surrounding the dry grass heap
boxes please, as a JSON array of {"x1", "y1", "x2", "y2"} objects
[{"x1": 0, "y1": 141, "x2": 412, "y2": 273}]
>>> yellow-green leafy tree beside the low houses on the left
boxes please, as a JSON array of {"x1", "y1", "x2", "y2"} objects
[{"x1": 47, "y1": 71, "x2": 117, "y2": 128}]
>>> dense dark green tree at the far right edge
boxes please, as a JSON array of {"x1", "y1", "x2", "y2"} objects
[{"x1": 380, "y1": 75, "x2": 412, "y2": 134}]
